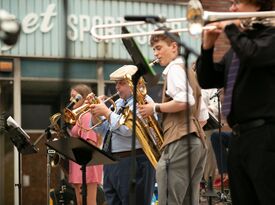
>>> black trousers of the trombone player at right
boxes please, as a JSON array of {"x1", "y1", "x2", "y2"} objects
[{"x1": 228, "y1": 124, "x2": 275, "y2": 205}]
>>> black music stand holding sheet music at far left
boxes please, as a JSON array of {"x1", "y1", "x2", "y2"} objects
[{"x1": 6, "y1": 126, "x2": 38, "y2": 205}]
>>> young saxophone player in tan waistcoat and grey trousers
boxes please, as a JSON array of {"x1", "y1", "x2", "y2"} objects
[{"x1": 138, "y1": 30, "x2": 208, "y2": 205}]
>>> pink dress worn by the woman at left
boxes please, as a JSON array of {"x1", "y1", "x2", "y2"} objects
[{"x1": 69, "y1": 112, "x2": 103, "y2": 184}]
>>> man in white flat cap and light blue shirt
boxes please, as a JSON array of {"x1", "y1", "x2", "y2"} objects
[{"x1": 91, "y1": 65, "x2": 155, "y2": 205}]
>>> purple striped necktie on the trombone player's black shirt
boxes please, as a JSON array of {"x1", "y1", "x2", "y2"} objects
[{"x1": 222, "y1": 53, "x2": 240, "y2": 117}]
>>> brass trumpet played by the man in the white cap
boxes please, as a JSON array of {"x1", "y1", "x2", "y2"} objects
[{"x1": 64, "y1": 92, "x2": 119, "y2": 130}]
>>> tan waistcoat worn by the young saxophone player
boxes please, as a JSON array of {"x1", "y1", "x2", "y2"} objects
[{"x1": 161, "y1": 66, "x2": 205, "y2": 149}]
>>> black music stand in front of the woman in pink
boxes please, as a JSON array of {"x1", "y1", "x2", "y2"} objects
[{"x1": 46, "y1": 137, "x2": 116, "y2": 205}]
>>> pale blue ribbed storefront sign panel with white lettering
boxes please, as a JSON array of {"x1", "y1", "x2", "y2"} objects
[{"x1": 0, "y1": 0, "x2": 201, "y2": 60}]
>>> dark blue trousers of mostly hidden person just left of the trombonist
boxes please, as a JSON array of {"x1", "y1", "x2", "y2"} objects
[{"x1": 211, "y1": 131, "x2": 232, "y2": 174}]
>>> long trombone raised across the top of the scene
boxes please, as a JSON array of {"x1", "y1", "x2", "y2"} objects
[{"x1": 91, "y1": 0, "x2": 275, "y2": 40}]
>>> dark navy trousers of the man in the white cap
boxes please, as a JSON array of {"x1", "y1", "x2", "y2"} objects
[{"x1": 103, "y1": 154, "x2": 155, "y2": 205}]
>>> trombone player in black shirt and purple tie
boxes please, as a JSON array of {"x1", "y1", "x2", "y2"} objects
[{"x1": 196, "y1": 0, "x2": 275, "y2": 205}]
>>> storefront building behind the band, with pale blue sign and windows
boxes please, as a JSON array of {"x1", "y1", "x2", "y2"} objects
[{"x1": 0, "y1": 0, "x2": 231, "y2": 205}]
